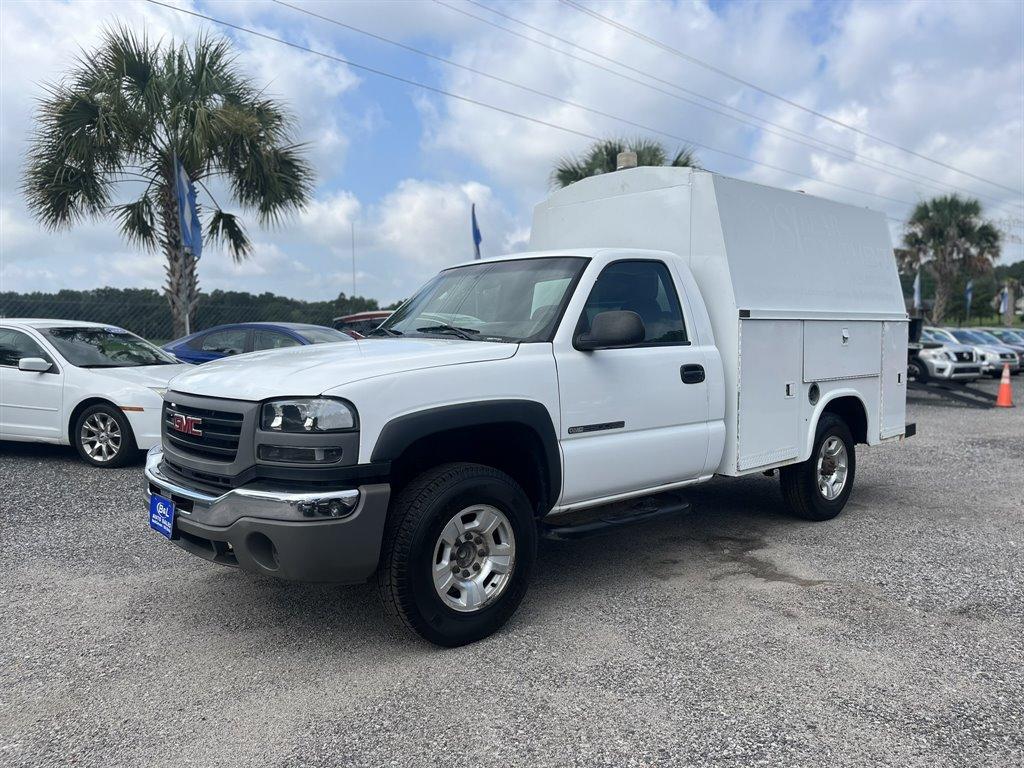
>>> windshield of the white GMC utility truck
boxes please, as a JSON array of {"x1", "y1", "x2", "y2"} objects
[{"x1": 373, "y1": 257, "x2": 587, "y2": 342}]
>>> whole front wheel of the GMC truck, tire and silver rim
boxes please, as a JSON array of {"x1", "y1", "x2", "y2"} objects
[{"x1": 377, "y1": 463, "x2": 537, "y2": 647}]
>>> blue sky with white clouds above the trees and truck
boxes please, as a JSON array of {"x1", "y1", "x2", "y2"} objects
[{"x1": 0, "y1": 0, "x2": 1024, "y2": 301}]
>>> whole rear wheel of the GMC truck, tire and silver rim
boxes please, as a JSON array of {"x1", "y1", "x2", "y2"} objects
[{"x1": 779, "y1": 414, "x2": 857, "y2": 520}]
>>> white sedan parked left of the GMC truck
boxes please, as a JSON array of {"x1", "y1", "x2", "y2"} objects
[{"x1": 0, "y1": 319, "x2": 191, "y2": 467}]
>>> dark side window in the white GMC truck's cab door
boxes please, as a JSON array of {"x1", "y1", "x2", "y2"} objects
[{"x1": 580, "y1": 261, "x2": 687, "y2": 344}]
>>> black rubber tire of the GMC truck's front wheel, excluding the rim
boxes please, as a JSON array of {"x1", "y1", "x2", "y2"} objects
[{"x1": 377, "y1": 463, "x2": 537, "y2": 647}]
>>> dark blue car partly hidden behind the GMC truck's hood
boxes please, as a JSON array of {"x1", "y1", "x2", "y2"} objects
[{"x1": 164, "y1": 323, "x2": 352, "y2": 362}]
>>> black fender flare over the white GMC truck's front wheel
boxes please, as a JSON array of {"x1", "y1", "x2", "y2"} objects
[{"x1": 370, "y1": 399, "x2": 562, "y2": 505}]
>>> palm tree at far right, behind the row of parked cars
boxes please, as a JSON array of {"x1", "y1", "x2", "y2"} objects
[{"x1": 897, "y1": 194, "x2": 1000, "y2": 324}]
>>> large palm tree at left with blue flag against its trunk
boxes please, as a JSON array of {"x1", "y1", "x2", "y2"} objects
[{"x1": 23, "y1": 27, "x2": 313, "y2": 335}]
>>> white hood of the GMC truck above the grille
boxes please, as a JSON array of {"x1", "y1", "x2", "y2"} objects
[{"x1": 170, "y1": 338, "x2": 518, "y2": 400}]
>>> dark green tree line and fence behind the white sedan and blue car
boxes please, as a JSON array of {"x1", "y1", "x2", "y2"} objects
[{"x1": 0, "y1": 289, "x2": 378, "y2": 344}]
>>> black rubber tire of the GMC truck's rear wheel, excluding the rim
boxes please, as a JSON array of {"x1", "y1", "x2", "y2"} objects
[{"x1": 778, "y1": 414, "x2": 857, "y2": 521}]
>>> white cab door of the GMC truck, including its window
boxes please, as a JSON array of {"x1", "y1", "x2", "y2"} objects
[{"x1": 555, "y1": 259, "x2": 709, "y2": 505}]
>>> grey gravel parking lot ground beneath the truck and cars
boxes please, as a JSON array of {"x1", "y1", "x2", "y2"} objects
[{"x1": 0, "y1": 377, "x2": 1024, "y2": 768}]
